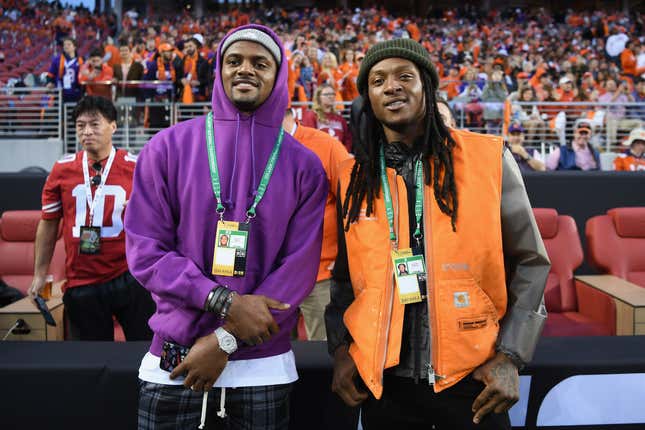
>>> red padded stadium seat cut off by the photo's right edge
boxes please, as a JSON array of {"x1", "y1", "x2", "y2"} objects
[{"x1": 586, "y1": 207, "x2": 645, "y2": 287}]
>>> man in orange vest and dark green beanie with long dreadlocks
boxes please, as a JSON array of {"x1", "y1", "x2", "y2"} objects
[{"x1": 325, "y1": 39, "x2": 550, "y2": 430}]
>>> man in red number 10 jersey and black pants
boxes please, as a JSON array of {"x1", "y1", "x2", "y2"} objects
[{"x1": 29, "y1": 96, "x2": 155, "y2": 340}]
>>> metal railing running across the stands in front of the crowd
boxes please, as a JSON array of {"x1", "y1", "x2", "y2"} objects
[{"x1": 0, "y1": 85, "x2": 645, "y2": 156}]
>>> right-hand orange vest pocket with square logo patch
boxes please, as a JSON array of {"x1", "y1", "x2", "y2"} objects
[{"x1": 433, "y1": 278, "x2": 499, "y2": 377}]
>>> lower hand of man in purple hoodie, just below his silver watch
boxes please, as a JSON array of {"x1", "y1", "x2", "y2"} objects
[{"x1": 170, "y1": 334, "x2": 228, "y2": 392}]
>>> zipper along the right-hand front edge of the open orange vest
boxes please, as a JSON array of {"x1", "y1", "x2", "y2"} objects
[{"x1": 423, "y1": 175, "x2": 445, "y2": 385}]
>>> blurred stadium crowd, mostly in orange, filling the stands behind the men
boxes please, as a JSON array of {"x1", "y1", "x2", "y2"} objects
[{"x1": 0, "y1": 0, "x2": 645, "y2": 149}]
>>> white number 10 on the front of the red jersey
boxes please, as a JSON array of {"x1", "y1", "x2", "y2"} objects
[{"x1": 72, "y1": 184, "x2": 125, "y2": 237}]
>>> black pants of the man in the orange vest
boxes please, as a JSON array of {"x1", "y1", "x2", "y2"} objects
[{"x1": 361, "y1": 375, "x2": 511, "y2": 430}]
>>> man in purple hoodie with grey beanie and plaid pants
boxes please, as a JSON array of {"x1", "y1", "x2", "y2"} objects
[{"x1": 125, "y1": 25, "x2": 327, "y2": 429}]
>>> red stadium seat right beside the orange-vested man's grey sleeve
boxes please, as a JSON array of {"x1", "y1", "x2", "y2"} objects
[{"x1": 533, "y1": 208, "x2": 616, "y2": 336}]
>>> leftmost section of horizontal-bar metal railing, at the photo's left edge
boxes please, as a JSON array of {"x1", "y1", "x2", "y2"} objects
[{"x1": 0, "y1": 87, "x2": 63, "y2": 139}]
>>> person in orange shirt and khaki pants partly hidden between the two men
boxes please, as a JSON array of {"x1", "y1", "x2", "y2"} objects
[{"x1": 282, "y1": 109, "x2": 351, "y2": 340}]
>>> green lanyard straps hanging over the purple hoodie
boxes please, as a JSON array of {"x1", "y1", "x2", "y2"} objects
[{"x1": 206, "y1": 112, "x2": 284, "y2": 224}]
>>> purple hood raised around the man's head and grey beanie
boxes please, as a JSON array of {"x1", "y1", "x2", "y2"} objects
[{"x1": 212, "y1": 24, "x2": 289, "y2": 127}]
